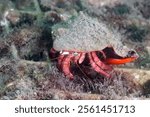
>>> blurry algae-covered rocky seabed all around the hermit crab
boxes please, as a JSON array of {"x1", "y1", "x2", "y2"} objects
[{"x1": 0, "y1": 0, "x2": 150, "y2": 99}]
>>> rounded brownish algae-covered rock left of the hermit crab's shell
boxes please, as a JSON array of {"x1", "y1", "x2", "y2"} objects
[{"x1": 8, "y1": 26, "x2": 44, "y2": 59}]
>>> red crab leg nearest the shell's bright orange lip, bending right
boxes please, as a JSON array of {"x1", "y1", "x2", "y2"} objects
[{"x1": 91, "y1": 52, "x2": 112, "y2": 70}]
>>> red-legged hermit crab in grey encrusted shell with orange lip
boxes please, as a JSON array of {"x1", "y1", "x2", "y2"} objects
[{"x1": 50, "y1": 12, "x2": 138, "y2": 79}]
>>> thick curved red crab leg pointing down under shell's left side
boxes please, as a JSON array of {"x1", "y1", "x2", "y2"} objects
[{"x1": 61, "y1": 55, "x2": 73, "y2": 79}]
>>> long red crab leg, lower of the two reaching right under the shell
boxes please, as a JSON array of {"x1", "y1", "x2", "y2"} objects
[{"x1": 88, "y1": 53, "x2": 110, "y2": 78}]
